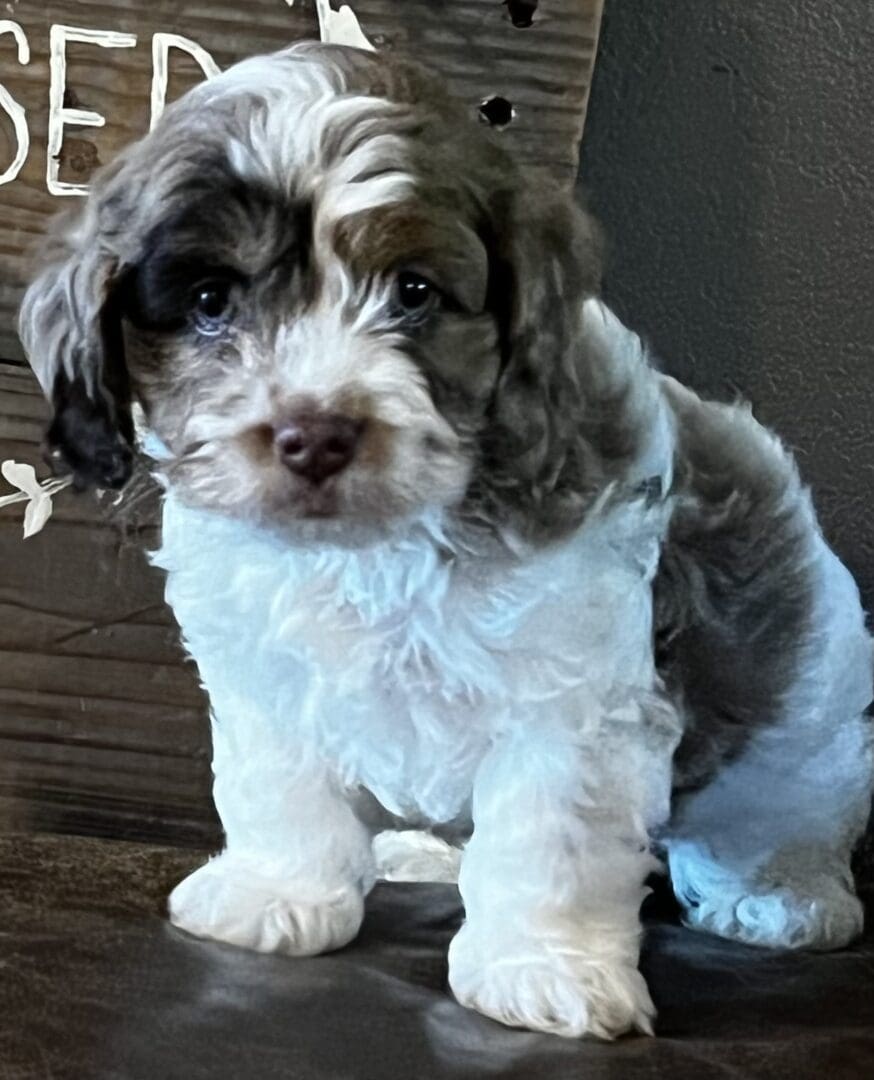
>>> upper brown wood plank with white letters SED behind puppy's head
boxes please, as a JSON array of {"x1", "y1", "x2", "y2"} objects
[{"x1": 0, "y1": 0, "x2": 603, "y2": 359}]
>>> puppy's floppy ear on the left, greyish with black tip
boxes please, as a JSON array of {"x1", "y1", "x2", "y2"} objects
[{"x1": 18, "y1": 195, "x2": 133, "y2": 488}]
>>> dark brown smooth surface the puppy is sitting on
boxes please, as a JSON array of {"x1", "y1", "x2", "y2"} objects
[{"x1": 0, "y1": 835, "x2": 874, "y2": 1080}]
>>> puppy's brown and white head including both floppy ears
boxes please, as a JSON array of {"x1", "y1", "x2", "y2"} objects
[{"x1": 21, "y1": 44, "x2": 622, "y2": 544}]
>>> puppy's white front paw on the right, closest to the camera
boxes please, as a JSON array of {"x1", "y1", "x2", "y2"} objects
[{"x1": 449, "y1": 926, "x2": 655, "y2": 1039}]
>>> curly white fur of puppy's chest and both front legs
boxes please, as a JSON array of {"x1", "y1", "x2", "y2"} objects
[{"x1": 150, "y1": 308, "x2": 680, "y2": 1036}]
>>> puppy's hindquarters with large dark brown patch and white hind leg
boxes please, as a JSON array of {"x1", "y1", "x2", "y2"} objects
[{"x1": 655, "y1": 379, "x2": 872, "y2": 948}]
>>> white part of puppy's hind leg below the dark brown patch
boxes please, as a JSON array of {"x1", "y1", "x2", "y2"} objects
[{"x1": 667, "y1": 553, "x2": 872, "y2": 949}]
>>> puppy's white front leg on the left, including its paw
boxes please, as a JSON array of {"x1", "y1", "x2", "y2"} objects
[{"x1": 169, "y1": 715, "x2": 374, "y2": 956}]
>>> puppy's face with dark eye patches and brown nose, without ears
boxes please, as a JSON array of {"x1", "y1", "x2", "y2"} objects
[{"x1": 120, "y1": 158, "x2": 499, "y2": 531}]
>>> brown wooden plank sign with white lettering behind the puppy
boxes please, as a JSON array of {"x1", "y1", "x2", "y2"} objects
[{"x1": 0, "y1": 0, "x2": 601, "y2": 846}]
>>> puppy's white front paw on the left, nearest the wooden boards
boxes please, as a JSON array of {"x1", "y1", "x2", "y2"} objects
[{"x1": 167, "y1": 852, "x2": 364, "y2": 956}]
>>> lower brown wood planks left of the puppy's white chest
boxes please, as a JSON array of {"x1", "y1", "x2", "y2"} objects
[{"x1": 0, "y1": 365, "x2": 219, "y2": 845}]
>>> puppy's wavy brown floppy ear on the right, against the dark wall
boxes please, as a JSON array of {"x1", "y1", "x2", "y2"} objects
[{"x1": 483, "y1": 188, "x2": 604, "y2": 531}]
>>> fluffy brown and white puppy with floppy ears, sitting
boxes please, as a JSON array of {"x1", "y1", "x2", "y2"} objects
[{"x1": 21, "y1": 44, "x2": 872, "y2": 1037}]
